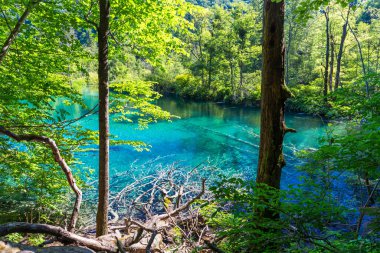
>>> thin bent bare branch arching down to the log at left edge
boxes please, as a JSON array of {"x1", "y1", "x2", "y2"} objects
[{"x1": 0, "y1": 126, "x2": 82, "y2": 231}]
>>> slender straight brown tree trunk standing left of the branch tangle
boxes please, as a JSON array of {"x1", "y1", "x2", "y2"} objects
[{"x1": 96, "y1": 0, "x2": 110, "y2": 236}]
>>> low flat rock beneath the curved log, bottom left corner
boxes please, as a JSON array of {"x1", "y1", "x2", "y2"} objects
[{"x1": 0, "y1": 241, "x2": 95, "y2": 253}]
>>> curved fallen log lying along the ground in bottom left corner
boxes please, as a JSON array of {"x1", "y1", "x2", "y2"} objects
[{"x1": 0, "y1": 222, "x2": 116, "y2": 252}]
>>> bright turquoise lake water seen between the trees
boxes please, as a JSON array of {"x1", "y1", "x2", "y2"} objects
[{"x1": 56, "y1": 87, "x2": 325, "y2": 187}]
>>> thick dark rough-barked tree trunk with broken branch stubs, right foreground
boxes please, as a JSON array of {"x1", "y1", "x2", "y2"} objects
[{"x1": 256, "y1": 0, "x2": 291, "y2": 194}]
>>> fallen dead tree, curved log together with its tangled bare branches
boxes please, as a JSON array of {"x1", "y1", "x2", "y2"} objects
[{"x1": 0, "y1": 164, "x2": 221, "y2": 253}]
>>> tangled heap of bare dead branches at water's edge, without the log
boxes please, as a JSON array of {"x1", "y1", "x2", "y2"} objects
[{"x1": 105, "y1": 164, "x2": 215, "y2": 252}]
